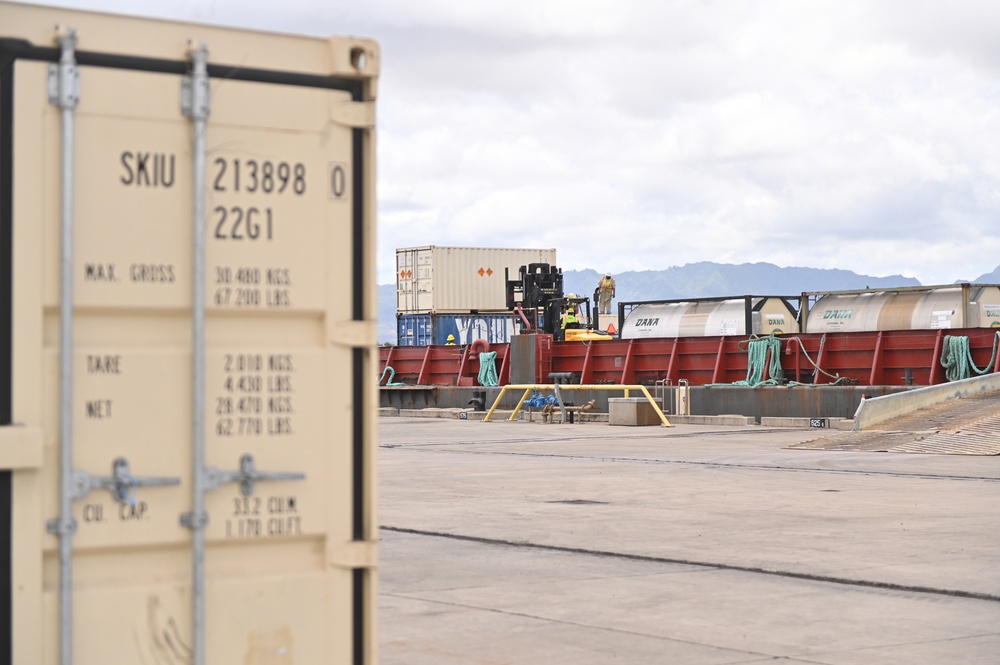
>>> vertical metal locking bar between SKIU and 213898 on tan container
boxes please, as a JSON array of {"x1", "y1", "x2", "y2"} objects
[{"x1": 182, "y1": 42, "x2": 210, "y2": 665}]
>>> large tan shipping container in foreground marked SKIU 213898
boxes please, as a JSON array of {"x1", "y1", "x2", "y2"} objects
[{"x1": 0, "y1": 2, "x2": 379, "y2": 665}]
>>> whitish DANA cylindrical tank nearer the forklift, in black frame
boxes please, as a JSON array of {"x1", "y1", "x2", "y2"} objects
[{"x1": 621, "y1": 296, "x2": 798, "y2": 339}]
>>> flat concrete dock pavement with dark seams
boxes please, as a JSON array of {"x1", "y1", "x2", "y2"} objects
[{"x1": 378, "y1": 417, "x2": 1000, "y2": 665}]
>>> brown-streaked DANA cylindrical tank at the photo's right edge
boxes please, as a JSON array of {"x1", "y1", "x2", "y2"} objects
[{"x1": 806, "y1": 284, "x2": 1000, "y2": 333}]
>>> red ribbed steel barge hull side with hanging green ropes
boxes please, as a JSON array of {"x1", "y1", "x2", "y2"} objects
[{"x1": 379, "y1": 328, "x2": 1000, "y2": 386}]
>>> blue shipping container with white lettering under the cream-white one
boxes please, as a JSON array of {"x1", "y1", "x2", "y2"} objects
[{"x1": 396, "y1": 312, "x2": 516, "y2": 346}]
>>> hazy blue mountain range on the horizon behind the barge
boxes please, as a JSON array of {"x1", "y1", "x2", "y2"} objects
[{"x1": 378, "y1": 261, "x2": 1000, "y2": 344}]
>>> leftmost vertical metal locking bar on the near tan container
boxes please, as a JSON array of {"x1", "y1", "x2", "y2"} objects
[{"x1": 49, "y1": 27, "x2": 80, "y2": 665}]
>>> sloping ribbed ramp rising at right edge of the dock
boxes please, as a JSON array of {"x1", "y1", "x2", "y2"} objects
[{"x1": 788, "y1": 391, "x2": 1000, "y2": 455}]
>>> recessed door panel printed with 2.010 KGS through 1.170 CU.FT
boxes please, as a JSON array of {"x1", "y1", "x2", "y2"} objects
[{"x1": 205, "y1": 347, "x2": 333, "y2": 540}]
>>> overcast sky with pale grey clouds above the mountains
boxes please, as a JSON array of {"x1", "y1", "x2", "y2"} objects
[{"x1": 21, "y1": 0, "x2": 1000, "y2": 284}]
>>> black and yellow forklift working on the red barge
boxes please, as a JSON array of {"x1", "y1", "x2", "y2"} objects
[{"x1": 504, "y1": 263, "x2": 614, "y2": 342}]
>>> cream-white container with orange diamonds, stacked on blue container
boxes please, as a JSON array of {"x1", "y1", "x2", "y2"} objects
[{"x1": 396, "y1": 245, "x2": 556, "y2": 314}]
